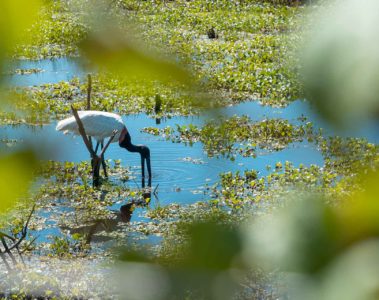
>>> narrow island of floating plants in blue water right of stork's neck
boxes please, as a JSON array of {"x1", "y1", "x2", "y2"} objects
[{"x1": 142, "y1": 116, "x2": 318, "y2": 159}]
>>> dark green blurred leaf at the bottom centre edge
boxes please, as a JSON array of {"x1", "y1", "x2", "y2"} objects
[{"x1": 169, "y1": 221, "x2": 243, "y2": 299}]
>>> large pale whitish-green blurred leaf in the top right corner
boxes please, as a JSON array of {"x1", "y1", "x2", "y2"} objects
[{"x1": 303, "y1": 0, "x2": 379, "y2": 127}]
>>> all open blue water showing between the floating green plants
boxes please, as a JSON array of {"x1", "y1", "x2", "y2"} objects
[{"x1": 0, "y1": 58, "x2": 379, "y2": 247}]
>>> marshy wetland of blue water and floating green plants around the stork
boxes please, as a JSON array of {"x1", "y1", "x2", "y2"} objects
[{"x1": 0, "y1": 0, "x2": 379, "y2": 299}]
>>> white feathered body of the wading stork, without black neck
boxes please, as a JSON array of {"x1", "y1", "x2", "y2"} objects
[{"x1": 56, "y1": 110, "x2": 125, "y2": 142}]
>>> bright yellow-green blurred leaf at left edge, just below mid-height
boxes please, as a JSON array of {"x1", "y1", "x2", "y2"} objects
[{"x1": 0, "y1": 152, "x2": 37, "y2": 212}]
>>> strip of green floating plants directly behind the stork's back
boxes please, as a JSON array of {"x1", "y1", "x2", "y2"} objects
[{"x1": 6, "y1": 74, "x2": 211, "y2": 124}]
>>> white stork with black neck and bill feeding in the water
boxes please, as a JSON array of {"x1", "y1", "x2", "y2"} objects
[{"x1": 56, "y1": 110, "x2": 151, "y2": 182}]
